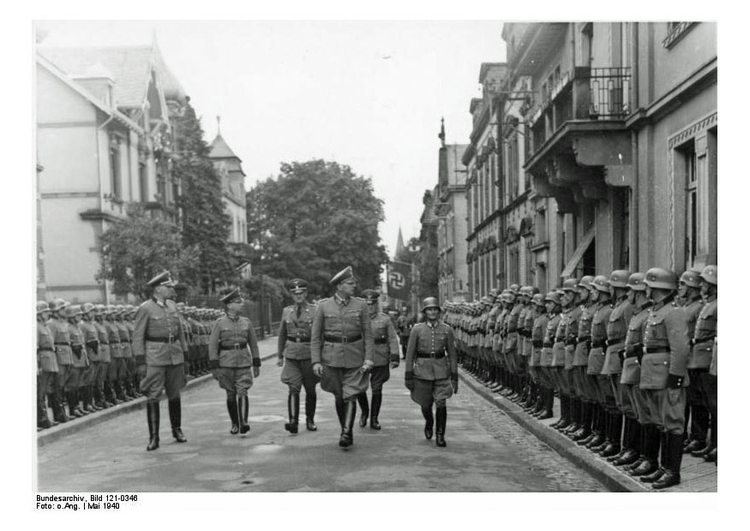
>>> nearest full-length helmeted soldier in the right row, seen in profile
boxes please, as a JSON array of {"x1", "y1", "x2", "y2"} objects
[{"x1": 640, "y1": 267, "x2": 689, "y2": 489}]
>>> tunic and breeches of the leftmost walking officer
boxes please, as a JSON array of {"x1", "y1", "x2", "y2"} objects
[{"x1": 134, "y1": 298, "x2": 187, "y2": 400}]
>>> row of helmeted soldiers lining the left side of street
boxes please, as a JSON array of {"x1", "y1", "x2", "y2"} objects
[{"x1": 36, "y1": 298, "x2": 223, "y2": 429}]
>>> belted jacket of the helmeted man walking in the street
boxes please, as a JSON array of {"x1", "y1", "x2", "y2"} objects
[{"x1": 406, "y1": 321, "x2": 458, "y2": 380}]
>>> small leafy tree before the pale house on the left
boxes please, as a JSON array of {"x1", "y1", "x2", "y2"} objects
[{"x1": 97, "y1": 204, "x2": 198, "y2": 299}]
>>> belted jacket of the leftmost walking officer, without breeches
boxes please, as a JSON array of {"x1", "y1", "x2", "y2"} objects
[{"x1": 133, "y1": 299, "x2": 187, "y2": 367}]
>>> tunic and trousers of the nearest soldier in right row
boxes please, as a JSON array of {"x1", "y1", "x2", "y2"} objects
[{"x1": 640, "y1": 296, "x2": 689, "y2": 435}]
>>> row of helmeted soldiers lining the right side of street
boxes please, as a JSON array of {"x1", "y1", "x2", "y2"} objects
[{"x1": 445, "y1": 265, "x2": 717, "y2": 489}]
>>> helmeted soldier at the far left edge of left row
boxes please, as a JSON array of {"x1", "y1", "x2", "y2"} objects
[{"x1": 36, "y1": 301, "x2": 60, "y2": 429}]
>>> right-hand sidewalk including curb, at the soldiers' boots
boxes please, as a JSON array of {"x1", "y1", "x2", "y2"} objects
[{"x1": 459, "y1": 368, "x2": 717, "y2": 492}]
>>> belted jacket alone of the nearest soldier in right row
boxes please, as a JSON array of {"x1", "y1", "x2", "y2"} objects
[{"x1": 640, "y1": 297, "x2": 697, "y2": 389}]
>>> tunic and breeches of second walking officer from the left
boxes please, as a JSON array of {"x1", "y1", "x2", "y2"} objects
[{"x1": 208, "y1": 315, "x2": 260, "y2": 398}]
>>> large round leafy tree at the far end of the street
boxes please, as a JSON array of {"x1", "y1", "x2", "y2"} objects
[{"x1": 247, "y1": 160, "x2": 388, "y2": 297}]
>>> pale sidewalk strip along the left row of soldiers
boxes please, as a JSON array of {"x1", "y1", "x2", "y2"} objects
[{"x1": 36, "y1": 336, "x2": 278, "y2": 448}]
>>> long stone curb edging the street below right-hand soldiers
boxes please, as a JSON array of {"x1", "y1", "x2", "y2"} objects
[{"x1": 459, "y1": 368, "x2": 651, "y2": 492}]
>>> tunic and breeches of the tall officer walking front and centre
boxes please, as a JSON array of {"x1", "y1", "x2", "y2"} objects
[{"x1": 310, "y1": 295, "x2": 375, "y2": 400}]
